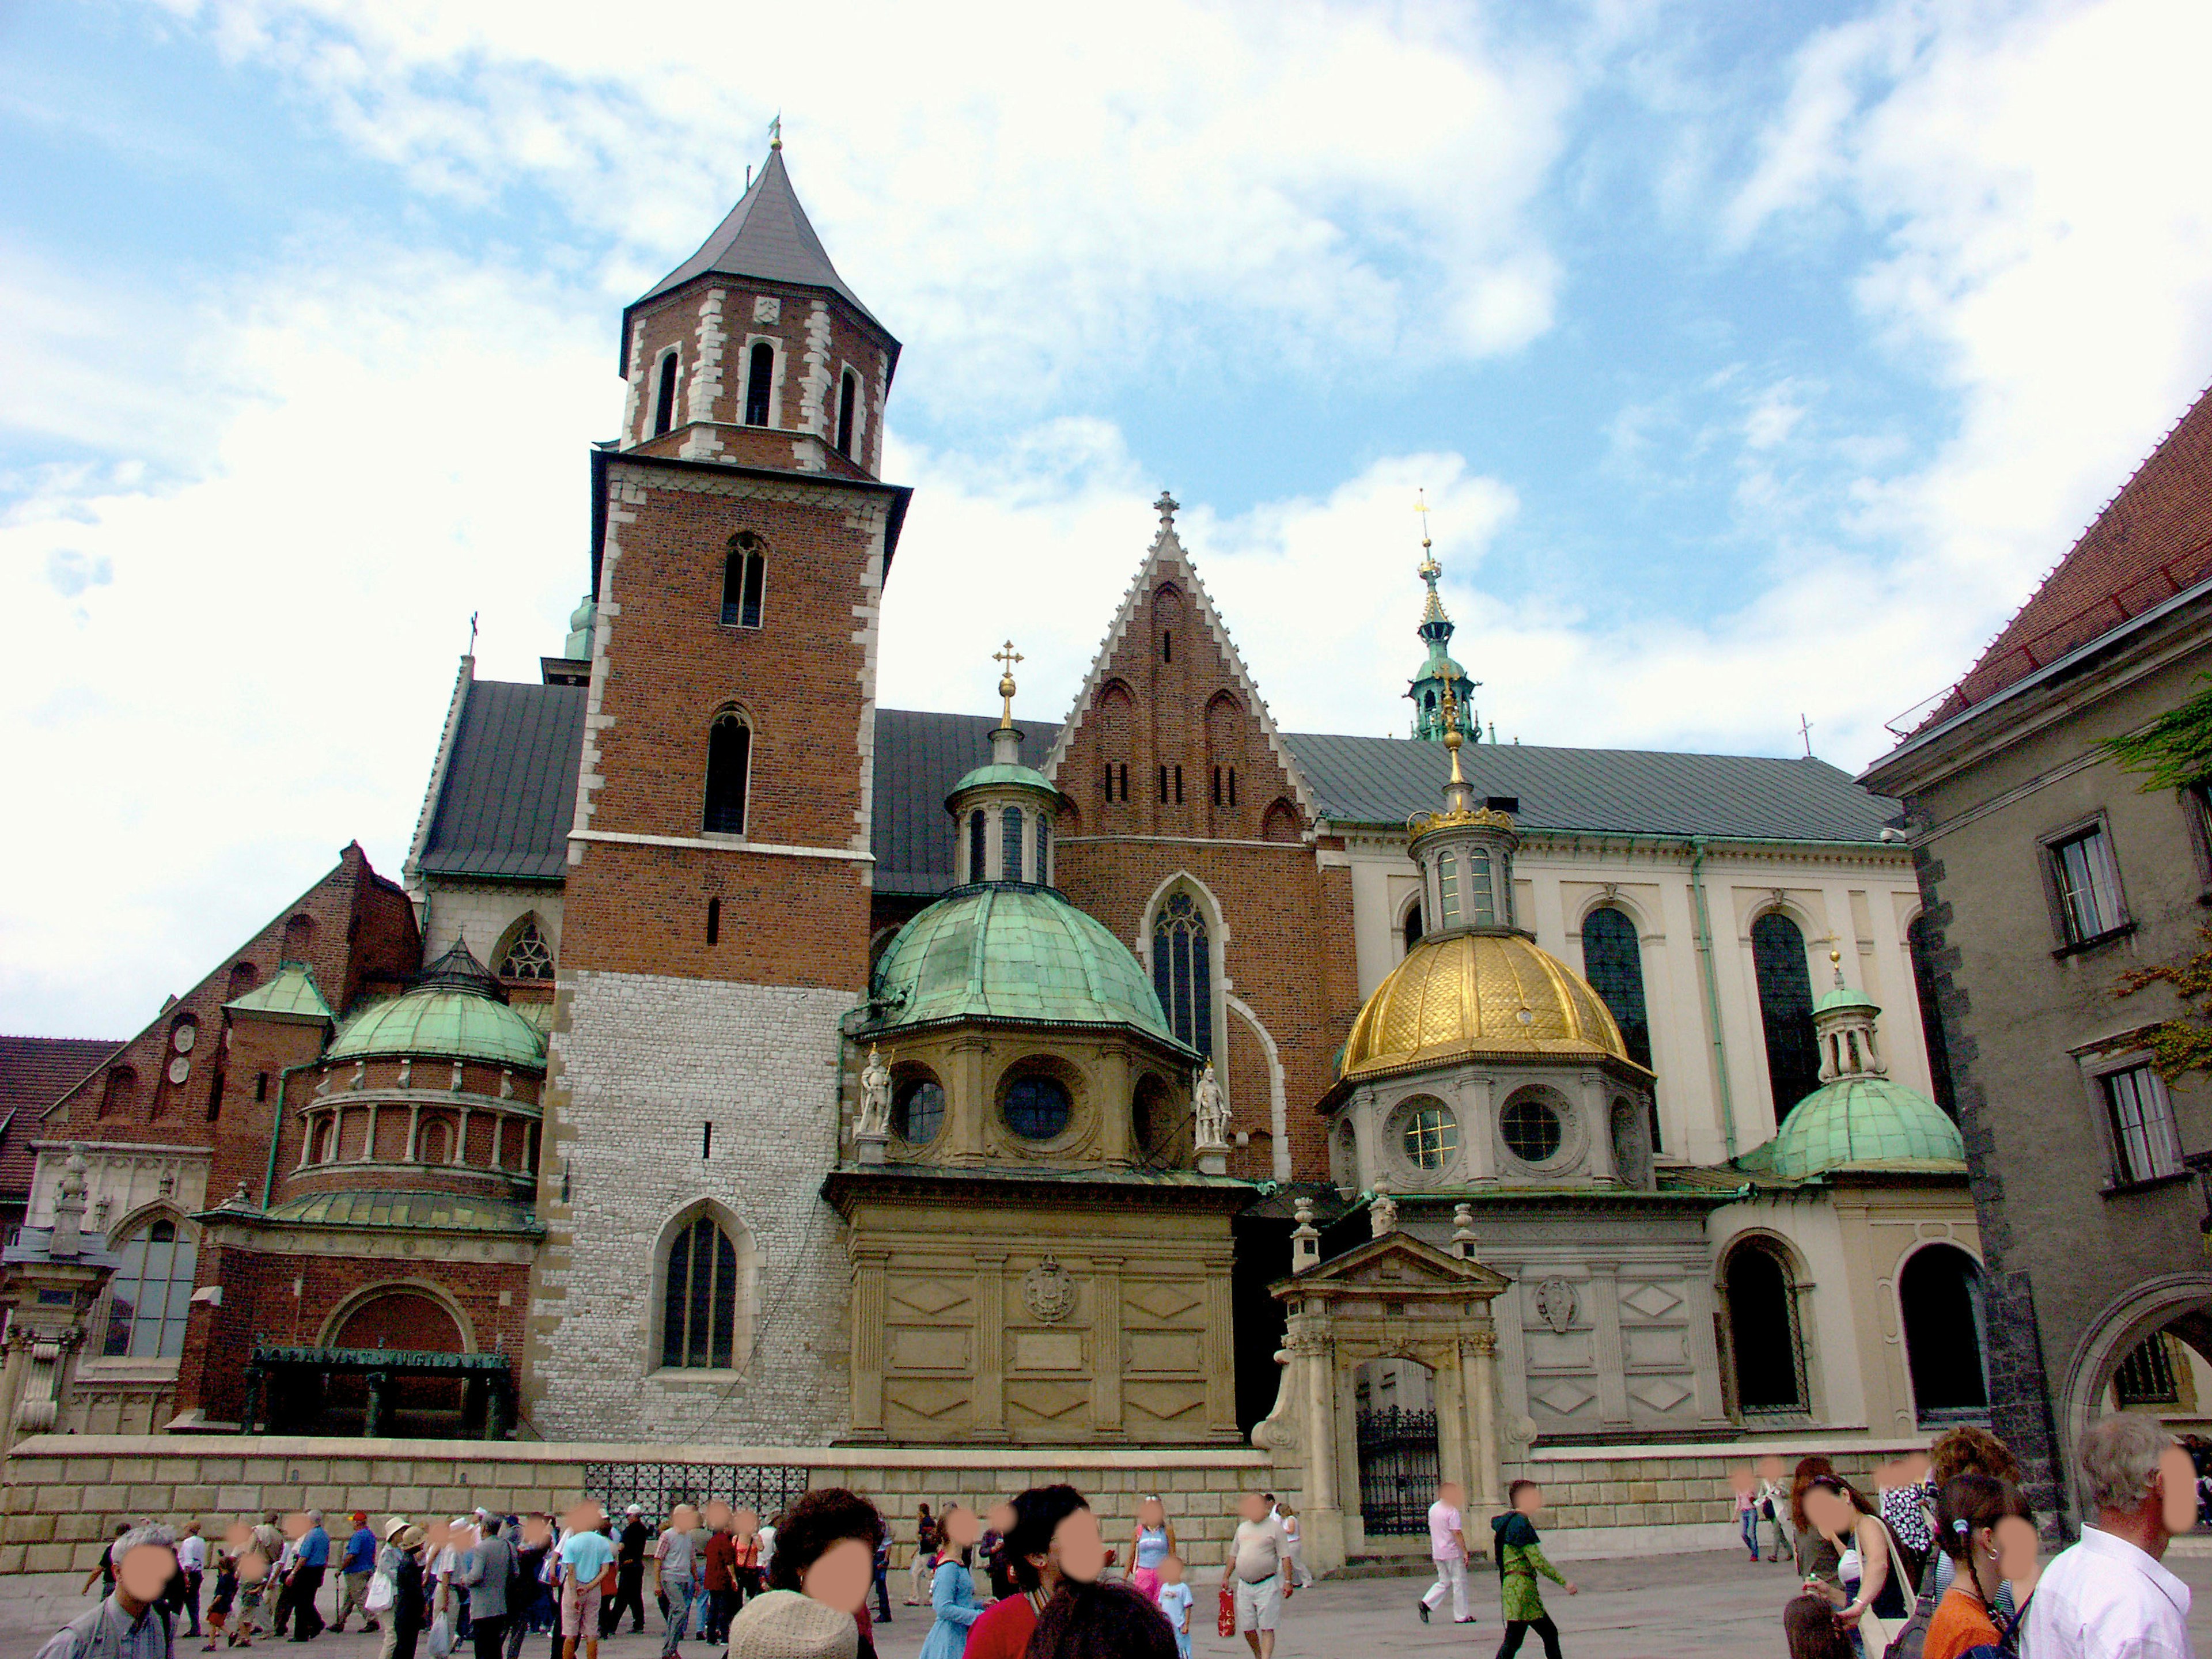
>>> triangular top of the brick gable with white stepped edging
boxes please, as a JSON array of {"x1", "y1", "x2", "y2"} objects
[{"x1": 1042, "y1": 493, "x2": 1314, "y2": 840}]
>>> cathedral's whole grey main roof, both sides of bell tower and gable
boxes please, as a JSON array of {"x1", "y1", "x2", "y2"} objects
[{"x1": 407, "y1": 679, "x2": 1898, "y2": 896}]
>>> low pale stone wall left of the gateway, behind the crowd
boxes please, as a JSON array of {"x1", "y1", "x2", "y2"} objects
[{"x1": 0, "y1": 1435, "x2": 1270, "y2": 1573}]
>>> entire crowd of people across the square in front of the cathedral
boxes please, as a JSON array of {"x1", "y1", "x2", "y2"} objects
[{"x1": 40, "y1": 1414, "x2": 2199, "y2": 1659}]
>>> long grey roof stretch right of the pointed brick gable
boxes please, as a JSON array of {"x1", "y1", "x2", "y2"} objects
[{"x1": 1283, "y1": 732, "x2": 1900, "y2": 843}]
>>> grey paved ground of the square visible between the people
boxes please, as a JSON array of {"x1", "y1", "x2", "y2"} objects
[{"x1": 13, "y1": 1540, "x2": 2212, "y2": 1659}]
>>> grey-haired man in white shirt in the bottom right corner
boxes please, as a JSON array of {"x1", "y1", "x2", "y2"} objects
[{"x1": 2024, "y1": 1411, "x2": 2196, "y2": 1659}]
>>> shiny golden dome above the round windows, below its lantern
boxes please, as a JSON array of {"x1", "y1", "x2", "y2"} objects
[{"x1": 1338, "y1": 933, "x2": 1633, "y2": 1080}]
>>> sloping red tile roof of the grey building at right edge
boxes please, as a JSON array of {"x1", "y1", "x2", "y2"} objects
[{"x1": 1922, "y1": 389, "x2": 2212, "y2": 726}]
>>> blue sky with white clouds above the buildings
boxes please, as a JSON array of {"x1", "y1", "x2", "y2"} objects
[{"x1": 0, "y1": 0, "x2": 2212, "y2": 1035}]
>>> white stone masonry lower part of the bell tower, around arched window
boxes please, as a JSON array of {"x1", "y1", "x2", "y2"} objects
[{"x1": 524, "y1": 971, "x2": 854, "y2": 1445}]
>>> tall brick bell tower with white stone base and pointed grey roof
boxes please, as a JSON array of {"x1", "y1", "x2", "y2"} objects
[{"x1": 524, "y1": 139, "x2": 909, "y2": 1445}]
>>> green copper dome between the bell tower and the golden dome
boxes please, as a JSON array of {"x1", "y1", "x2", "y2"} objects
[{"x1": 872, "y1": 887, "x2": 1196, "y2": 1058}]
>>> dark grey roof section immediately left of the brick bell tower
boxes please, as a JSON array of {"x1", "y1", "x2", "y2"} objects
[{"x1": 421, "y1": 679, "x2": 590, "y2": 880}]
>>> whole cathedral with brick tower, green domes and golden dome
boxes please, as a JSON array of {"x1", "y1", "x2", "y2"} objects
[{"x1": 0, "y1": 144, "x2": 1988, "y2": 1555}]
